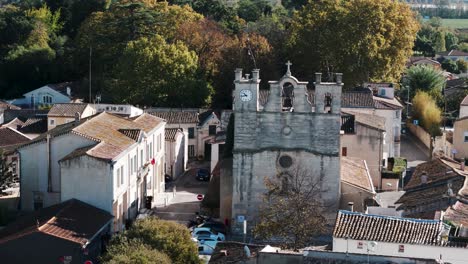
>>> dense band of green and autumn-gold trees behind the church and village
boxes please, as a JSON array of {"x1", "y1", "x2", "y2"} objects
[{"x1": 0, "y1": 0, "x2": 420, "y2": 108}]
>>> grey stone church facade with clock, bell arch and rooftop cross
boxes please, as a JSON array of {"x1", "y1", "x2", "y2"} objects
[{"x1": 231, "y1": 62, "x2": 343, "y2": 234}]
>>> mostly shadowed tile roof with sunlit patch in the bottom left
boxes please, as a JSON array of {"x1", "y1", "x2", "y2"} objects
[{"x1": 0, "y1": 199, "x2": 113, "y2": 246}]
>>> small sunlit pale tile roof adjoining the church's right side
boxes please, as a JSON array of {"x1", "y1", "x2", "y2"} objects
[{"x1": 340, "y1": 157, "x2": 375, "y2": 193}]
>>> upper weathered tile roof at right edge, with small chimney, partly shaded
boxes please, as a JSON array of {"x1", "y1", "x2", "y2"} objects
[{"x1": 404, "y1": 157, "x2": 468, "y2": 190}]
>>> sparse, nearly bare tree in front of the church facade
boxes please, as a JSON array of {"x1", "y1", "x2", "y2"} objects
[{"x1": 254, "y1": 166, "x2": 327, "y2": 250}]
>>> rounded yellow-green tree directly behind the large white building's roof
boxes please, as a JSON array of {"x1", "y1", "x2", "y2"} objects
[{"x1": 109, "y1": 36, "x2": 211, "y2": 107}]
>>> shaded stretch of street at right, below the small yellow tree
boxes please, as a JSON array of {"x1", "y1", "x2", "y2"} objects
[{"x1": 400, "y1": 133, "x2": 429, "y2": 169}]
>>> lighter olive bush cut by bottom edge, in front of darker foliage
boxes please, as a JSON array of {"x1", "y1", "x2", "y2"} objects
[{"x1": 101, "y1": 235, "x2": 171, "y2": 264}]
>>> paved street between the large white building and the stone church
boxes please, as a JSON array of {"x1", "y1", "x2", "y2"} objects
[{"x1": 155, "y1": 164, "x2": 208, "y2": 224}]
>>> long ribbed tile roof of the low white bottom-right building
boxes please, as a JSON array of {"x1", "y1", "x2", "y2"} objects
[{"x1": 333, "y1": 210, "x2": 449, "y2": 245}]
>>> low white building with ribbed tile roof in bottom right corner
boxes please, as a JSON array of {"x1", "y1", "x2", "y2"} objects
[{"x1": 333, "y1": 211, "x2": 468, "y2": 264}]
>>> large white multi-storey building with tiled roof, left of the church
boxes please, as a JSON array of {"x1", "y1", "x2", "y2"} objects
[{"x1": 18, "y1": 112, "x2": 165, "y2": 231}]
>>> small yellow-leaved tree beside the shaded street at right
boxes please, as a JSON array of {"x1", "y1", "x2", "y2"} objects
[{"x1": 413, "y1": 91, "x2": 442, "y2": 158}]
